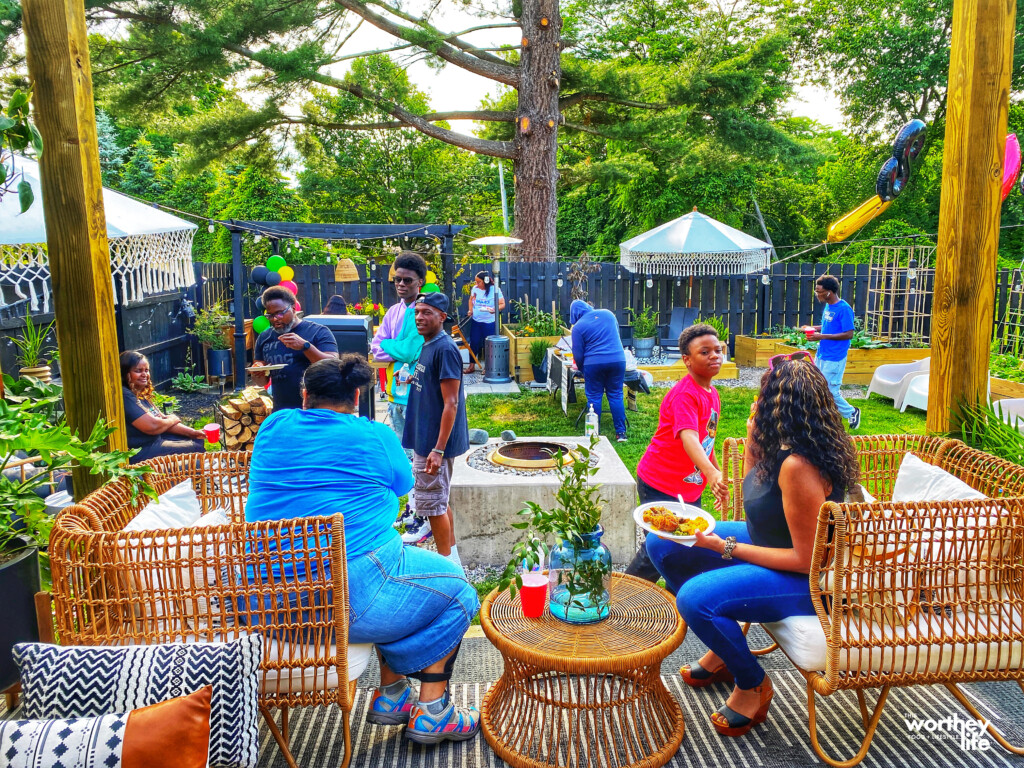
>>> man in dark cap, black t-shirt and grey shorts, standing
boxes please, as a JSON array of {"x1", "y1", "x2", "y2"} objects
[{"x1": 401, "y1": 293, "x2": 469, "y2": 567}]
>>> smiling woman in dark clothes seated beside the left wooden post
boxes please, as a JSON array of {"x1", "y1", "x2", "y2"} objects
[{"x1": 121, "y1": 349, "x2": 206, "y2": 464}]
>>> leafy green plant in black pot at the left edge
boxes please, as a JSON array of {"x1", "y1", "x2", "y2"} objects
[{"x1": 0, "y1": 377, "x2": 150, "y2": 690}]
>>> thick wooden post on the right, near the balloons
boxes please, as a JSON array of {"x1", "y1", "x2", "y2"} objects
[{"x1": 928, "y1": 0, "x2": 1017, "y2": 432}]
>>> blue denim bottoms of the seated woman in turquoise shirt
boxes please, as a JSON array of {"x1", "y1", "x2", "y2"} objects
[{"x1": 348, "y1": 536, "x2": 480, "y2": 675}]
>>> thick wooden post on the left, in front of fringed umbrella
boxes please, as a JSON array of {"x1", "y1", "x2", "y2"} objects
[{"x1": 22, "y1": 0, "x2": 126, "y2": 499}]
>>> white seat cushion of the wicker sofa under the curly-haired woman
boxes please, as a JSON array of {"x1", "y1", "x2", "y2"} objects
[{"x1": 763, "y1": 610, "x2": 1024, "y2": 674}]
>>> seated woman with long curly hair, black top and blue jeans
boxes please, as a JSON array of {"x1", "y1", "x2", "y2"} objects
[{"x1": 647, "y1": 352, "x2": 860, "y2": 736}]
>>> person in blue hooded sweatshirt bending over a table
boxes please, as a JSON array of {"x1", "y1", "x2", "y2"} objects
[{"x1": 569, "y1": 299, "x2": 626, "y2": 442}]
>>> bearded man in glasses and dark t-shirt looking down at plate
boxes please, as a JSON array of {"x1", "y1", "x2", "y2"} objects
[{"x1": 252, "y1": 286, "x2": 338, "y2": 411}]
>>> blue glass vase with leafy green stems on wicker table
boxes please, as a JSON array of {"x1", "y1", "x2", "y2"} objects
[{"x1": 499, "y1": 436, "x2": 611, "y2": 624}]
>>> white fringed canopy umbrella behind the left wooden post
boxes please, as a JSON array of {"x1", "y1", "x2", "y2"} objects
[{"x1": 0, "y1": 156, "x2": 197, "y2": 312}]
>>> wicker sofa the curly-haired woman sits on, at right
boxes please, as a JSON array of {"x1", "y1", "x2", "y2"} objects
[{"x1": 725, "y1": 435, "x2": 1024, "y2": 768}]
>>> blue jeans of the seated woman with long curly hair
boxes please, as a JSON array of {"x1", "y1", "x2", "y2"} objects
[{"x1": 647, "y1": 522, "x2": 814, "y2": 688}]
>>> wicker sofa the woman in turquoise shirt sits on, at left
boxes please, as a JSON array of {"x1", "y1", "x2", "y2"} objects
[{"x1": 50, "y1": 453, "x2": 370, "y2": 768}]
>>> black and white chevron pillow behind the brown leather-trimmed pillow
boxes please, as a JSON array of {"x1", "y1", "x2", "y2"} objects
[{"x1": 13, "y1": 634, "x2": 263, "y2": 768}]
